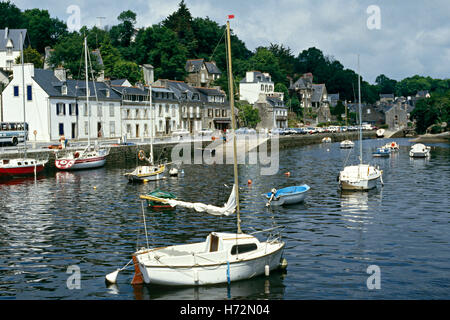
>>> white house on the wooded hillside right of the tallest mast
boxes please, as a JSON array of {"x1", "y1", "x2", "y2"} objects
[{"x1": 239, "y1": 71, "x2": 275, "y2": 104}]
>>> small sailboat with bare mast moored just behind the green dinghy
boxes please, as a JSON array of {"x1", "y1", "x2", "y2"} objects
[{"x1": 124, "y1": 85, "x2": 166, "y2": 182}]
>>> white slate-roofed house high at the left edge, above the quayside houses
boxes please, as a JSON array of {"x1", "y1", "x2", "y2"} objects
[{"x1": 0, "y1": 28, "x2": 27, "y2": 70}]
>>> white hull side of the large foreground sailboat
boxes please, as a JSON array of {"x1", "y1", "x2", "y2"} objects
[{"x1": 138, "y1": 243, "x2": 284, "y2": 286}]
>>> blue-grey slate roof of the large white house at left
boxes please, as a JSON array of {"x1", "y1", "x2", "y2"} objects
[{"x1": 33, "y1": 69, "x2": 120, "y2": 100}]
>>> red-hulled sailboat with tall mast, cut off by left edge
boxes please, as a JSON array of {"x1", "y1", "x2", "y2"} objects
[{"x1": 0, "y1": 32, "x2": 48, "y2": 179}]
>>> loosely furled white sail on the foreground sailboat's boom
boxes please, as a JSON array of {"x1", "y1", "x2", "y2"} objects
[{"x1": 140, "y1": 185, "x2": 236, "y2": 216}]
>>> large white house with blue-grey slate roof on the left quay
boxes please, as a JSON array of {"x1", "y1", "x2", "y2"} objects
[{"x1": 2, "y1": 63, "x2": 121, "y2": 141}]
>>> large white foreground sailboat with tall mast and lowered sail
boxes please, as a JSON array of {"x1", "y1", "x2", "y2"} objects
[{"x1": 106, "y1": 16, "x2": 286, "y2": 286}]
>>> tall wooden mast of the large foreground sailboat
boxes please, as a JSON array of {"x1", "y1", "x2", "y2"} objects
[{"x1": 227, "y1": 20, "x2": 242, "y2": 233}]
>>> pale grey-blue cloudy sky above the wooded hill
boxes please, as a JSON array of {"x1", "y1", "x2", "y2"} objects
[{"x1": 11, "y1": 0, "x2": 450, "y2": 83}]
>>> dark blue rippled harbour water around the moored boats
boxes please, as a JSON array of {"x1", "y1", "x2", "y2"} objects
[{"x1": 0, "y1": 139, "x2": 450, "y2": 299}]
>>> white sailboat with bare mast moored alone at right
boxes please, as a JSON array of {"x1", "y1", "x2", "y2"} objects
[{"x1": 338, "y1": 55, "x2": 383, "y2": 190}]
